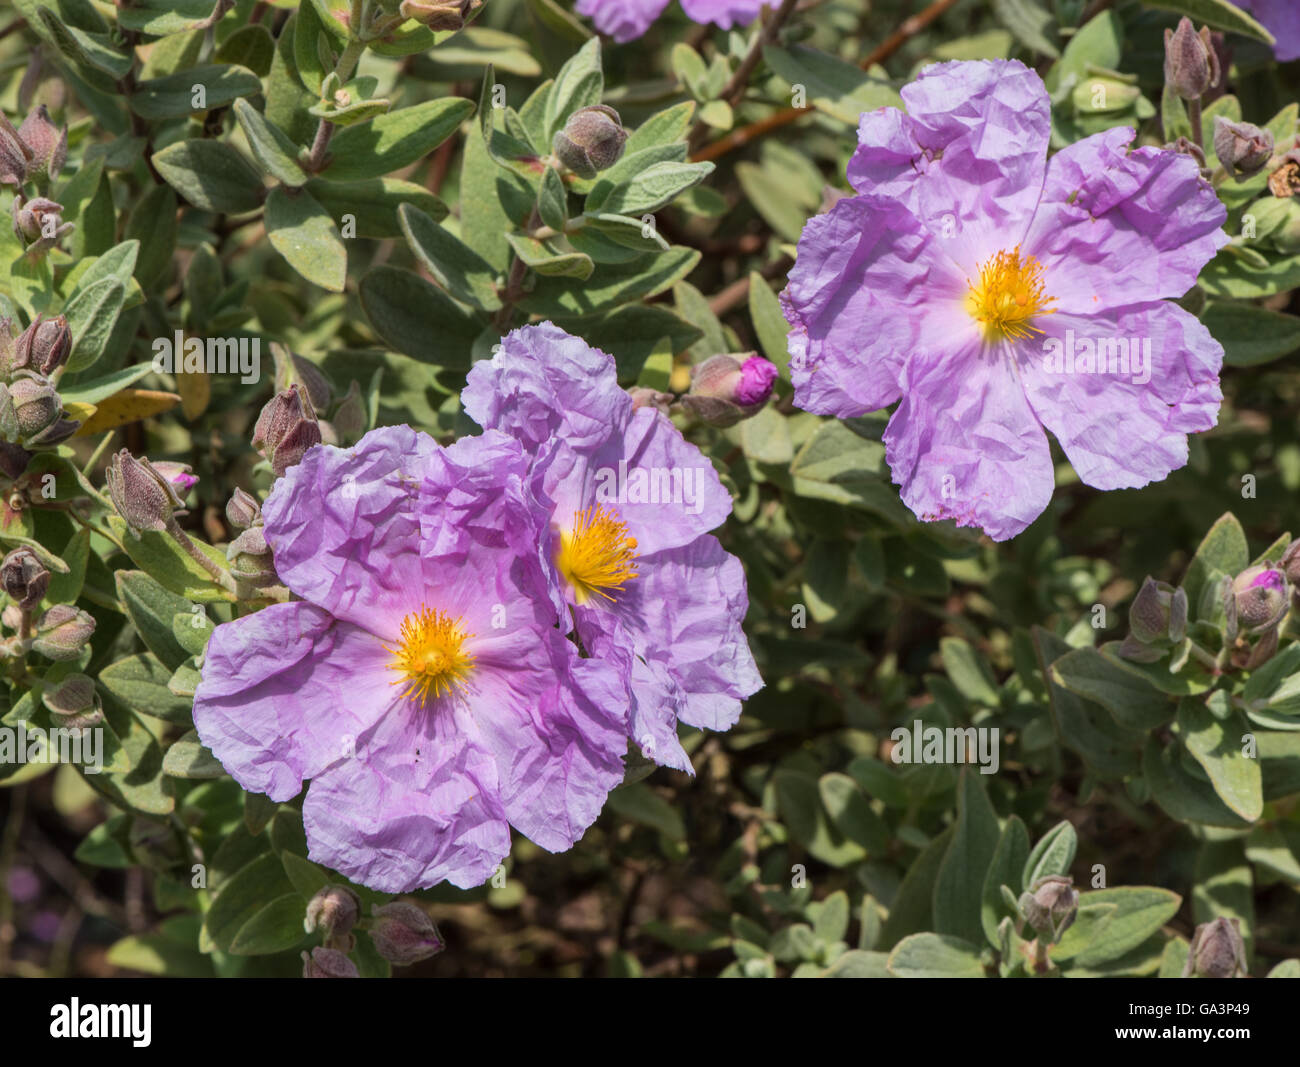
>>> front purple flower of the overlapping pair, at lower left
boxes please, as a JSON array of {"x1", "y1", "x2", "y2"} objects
[{"x1": 194, "y1": 426, "x2": 627, "y2": 893}]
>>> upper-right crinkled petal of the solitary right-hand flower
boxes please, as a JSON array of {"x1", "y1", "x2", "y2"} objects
[{"x1": 1022, "y1": 127, "x2": 1227, "y2": 315}]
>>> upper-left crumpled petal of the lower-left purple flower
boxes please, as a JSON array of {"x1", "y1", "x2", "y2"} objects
[{"x1": 263, "y1": 426, "x2": 438, "y2": 637}]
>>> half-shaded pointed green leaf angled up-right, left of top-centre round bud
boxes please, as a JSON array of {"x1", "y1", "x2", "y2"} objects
[{"x1": 321, "y1": 96, "x2": 475, "y2": 182}]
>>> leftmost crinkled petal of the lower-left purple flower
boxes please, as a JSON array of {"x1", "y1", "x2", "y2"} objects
[{"x1": 194, "y1": 602, "x2": 399, "y2": 802}]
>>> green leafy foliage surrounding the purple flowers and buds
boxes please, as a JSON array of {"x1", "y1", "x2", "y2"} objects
[{"x1": 0, "y1": 0, "x2": 1300, "y2": 976}]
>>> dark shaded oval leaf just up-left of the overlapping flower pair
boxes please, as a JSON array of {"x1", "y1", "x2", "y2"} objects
[{"x1": 360, "y1": 266, "x2": 482, "y2": 370}]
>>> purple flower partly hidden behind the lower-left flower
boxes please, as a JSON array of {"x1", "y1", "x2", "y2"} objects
[{"x1": 462, "y1": 322, "x2": 762, "y2": 771}]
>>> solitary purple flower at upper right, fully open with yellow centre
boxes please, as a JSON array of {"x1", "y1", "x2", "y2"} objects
[{"x1": 781, "y1": 60, "x2": 1227, "y2": 541}]
